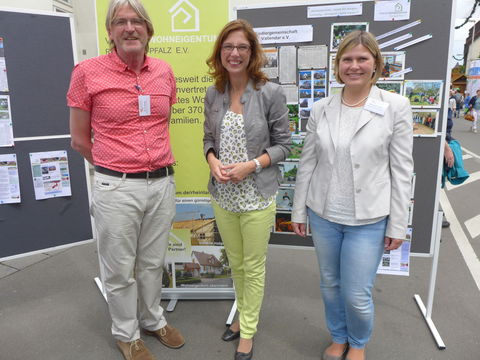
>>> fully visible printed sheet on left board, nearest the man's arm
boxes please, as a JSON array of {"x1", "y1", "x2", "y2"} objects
[{"x1": 30, "y1": 150, "x2": 72, "y2": 200}]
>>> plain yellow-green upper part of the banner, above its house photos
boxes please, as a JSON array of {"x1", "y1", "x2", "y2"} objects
[{"x1": 96, "y1": 0, "x2": 228, "y2": 197}]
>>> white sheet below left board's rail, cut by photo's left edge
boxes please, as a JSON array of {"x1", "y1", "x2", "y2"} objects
[{"x1": 0, "y1": 154, "x2": 20, "y2": 204}]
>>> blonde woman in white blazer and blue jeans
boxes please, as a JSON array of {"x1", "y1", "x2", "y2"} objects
[{"x1": 292, "y1": 31, "x2": 413, "y2": 360}]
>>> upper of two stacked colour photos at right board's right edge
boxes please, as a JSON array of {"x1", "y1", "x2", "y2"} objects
[{"x1": 403, "y1": 80, "x2": 443, "y2": 108}]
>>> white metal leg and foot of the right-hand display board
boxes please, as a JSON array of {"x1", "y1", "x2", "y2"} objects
[{"x1": 413, "y1": 211, "x2": 446, "y2": 350}]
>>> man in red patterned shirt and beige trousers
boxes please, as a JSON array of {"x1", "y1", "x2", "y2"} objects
[{"x1": 67, "y1": 0, "x2": 185, "y2": 360}]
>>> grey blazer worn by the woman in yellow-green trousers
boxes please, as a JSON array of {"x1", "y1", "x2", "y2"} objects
[{"x1": 203, "y1": 81, "x2": 291, "y2": 198}]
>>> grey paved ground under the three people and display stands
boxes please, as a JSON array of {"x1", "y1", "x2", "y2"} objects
[{"x1": 0, "y1": 230, "x2": 480, "y2": 360}]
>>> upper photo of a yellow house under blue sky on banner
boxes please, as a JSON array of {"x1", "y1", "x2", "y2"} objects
[{"x1": 173, "y1": 204, "x2": 223, "y2": 246}]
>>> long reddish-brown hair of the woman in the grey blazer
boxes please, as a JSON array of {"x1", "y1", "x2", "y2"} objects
[{"x1": 207, "y1": 19, "x2": 268, "y2": 93}]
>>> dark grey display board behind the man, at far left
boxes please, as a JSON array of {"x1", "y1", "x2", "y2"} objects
[{"x1": 0, "y1": 9, "x2": 92, "y2": 259}]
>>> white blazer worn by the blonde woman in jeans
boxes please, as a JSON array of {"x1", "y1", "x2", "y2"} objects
[{"x1": 292, "y1": 86, "x2": 413, "y2": 239}]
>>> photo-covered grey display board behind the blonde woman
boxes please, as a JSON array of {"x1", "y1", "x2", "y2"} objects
[{"x1": 235, "y1": 0, "x2": 452, "y2": 254}]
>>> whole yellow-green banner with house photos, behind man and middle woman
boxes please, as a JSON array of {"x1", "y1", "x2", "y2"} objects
[{"x1": 96, "y1": 0, "x2": 233, "y2": 296}]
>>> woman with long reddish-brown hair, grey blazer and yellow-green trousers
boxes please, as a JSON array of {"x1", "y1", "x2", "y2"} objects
[{"x1": 203, "y1": 20, "x2": 291, "y2": 360}]
